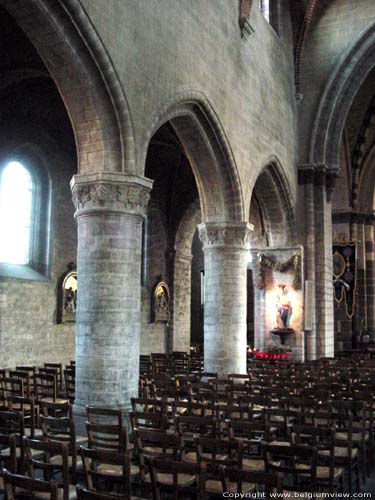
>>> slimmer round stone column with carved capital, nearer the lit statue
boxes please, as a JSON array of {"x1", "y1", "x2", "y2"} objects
[{"x1": 198, "y1": 222, "x2": 250, "y2": 375}]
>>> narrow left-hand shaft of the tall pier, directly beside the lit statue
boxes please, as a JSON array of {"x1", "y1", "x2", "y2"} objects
[{"x1": 298, "y1": 164, "x2": 316, "y2": 361}]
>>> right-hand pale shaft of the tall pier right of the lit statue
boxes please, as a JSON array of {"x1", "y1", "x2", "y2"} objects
[{"x1": 314, "y1": 165, "x2": 334, "y2": 357}]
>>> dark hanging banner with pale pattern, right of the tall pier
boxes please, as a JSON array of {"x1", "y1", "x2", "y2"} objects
[{"x1": 333, "y1": 243, "x2": 356, "y2": 319}]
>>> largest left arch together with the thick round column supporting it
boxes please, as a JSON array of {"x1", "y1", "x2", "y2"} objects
[{"x1": 0, "y1": 0, "x2": 152, "y2": 421}]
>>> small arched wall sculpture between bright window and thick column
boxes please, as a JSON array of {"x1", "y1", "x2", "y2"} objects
[{"x1": 57, "y1": 262, "x2": 77, "y2": 323}]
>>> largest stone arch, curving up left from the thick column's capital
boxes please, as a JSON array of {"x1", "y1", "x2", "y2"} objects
[{"x1": 0, "y1": 0, "x2": 135, "y2": 174}]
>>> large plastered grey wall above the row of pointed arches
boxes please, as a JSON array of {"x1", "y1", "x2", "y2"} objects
[{"x1": 82, "y1": 0, "x2": 296, "y2": 207}]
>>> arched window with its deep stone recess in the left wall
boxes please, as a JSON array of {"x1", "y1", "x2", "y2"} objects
[{"x1": 0, "y1": 151, "x2": 51, "y2": 280}]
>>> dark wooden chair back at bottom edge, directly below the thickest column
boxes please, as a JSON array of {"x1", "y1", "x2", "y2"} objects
[{"x1": 81, "y1": 446, "x2": 131, "y2": 499}]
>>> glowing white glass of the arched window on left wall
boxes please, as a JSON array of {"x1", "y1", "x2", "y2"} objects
[{"x1": 0, "y1": 161, "x2": 33, "y2": 265}]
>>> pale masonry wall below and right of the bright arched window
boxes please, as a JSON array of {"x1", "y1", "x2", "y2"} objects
[{"x1": 0, "y1": 145, "x2": 77, "y2": 367}]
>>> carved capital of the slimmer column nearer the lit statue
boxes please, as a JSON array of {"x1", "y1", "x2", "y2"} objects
[{"x1": 198, "y1": 222, "x2": 254, "y2": 250}]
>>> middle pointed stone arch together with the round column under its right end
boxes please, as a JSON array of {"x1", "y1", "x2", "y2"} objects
[{"x1": 144, "y1": 91, "x2": 249, "y2": 374}]
